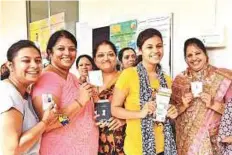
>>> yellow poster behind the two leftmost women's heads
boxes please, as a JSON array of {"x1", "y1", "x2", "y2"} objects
[{"x1": 29, "y1": 12, "x2": 65, "y2": 64}]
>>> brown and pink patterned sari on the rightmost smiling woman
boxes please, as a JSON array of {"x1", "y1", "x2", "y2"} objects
[{"x1": 171, "y1": 65, "x2": 232, "y2": 155}]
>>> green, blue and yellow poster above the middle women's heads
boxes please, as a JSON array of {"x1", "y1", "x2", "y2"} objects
[{"x1": 110, "y1": 20, "x2": 137, "y2": 51}]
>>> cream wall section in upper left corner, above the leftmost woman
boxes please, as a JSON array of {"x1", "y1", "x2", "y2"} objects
[{"x1": 0, "y1": 0, "x2": 27, "y2": 65}]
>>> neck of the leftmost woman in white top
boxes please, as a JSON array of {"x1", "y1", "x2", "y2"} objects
[{"x1": 8, "y1": 76, "x2": 29, "y2": 97}]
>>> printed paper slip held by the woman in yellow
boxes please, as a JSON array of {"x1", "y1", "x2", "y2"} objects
[{"x1": 155, "y1": 88, "x2": 171, "y2": 122}]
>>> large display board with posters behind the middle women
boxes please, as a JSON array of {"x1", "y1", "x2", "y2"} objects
[{"x1": 79, "y1": 14, "x2": 173, "y2": 76}]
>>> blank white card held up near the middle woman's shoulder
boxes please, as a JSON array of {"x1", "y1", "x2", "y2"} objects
[{"x1": 88, "y1": 70, "x2": 103, "y2": 86}]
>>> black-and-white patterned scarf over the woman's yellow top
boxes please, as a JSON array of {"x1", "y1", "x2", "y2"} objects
[{"x1": 137, "y1": 62, "x2": 177, "y2": 155}]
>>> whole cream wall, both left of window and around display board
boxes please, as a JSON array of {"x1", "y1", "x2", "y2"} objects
[{"x1": 0, "y1": 0, "x2": 232, "y2": 75}]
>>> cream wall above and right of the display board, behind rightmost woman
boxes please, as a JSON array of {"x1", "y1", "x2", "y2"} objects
[{"x1": 79, "y1": 0, "x2": 232, "y2": 76}]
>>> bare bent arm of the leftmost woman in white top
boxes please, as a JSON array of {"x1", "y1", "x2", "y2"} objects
[{"x1": 1, "y1": 108, "x2": 47, "y2": 155}]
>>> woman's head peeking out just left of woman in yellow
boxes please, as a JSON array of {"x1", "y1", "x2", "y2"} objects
[{"x1": 118, "y1": 47, "x2": 136, "y2": 70}]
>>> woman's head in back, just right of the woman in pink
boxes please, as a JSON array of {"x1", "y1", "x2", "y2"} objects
[{"x1": 76, "y1": 54, "x2": 96, "y2": 82}]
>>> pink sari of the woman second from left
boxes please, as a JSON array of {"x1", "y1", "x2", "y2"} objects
[{"x1": 32, "y1": 72, "x2": 99, "y2": 155}]
